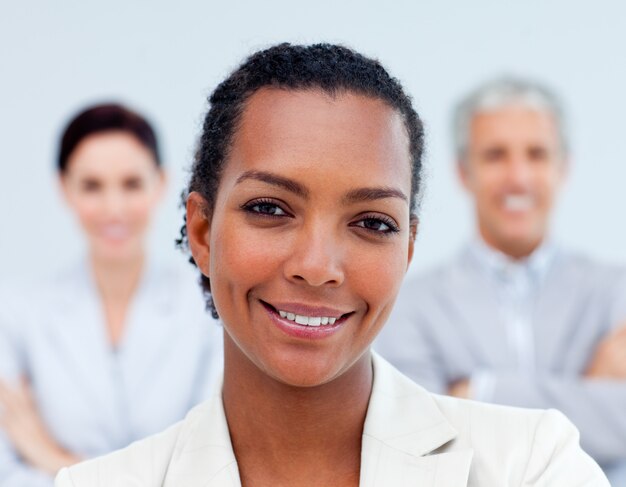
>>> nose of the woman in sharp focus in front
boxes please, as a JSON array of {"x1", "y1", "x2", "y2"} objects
[{"x1": 284, "y1": 225, "x2": 345, "y2": 287}]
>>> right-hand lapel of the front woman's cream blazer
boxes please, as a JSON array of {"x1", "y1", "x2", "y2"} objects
[{"x1": 360, "y1": 354, "x2": 473, "y2": 487}]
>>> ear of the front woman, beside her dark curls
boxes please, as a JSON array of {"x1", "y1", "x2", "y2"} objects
[{"x1": 186, "y1": 191, "x2": 211, "y2": 277}]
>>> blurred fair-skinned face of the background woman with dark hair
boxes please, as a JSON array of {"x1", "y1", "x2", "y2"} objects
[{"x1": 61, "y1": 131, "x2": 164, "y2": 261}]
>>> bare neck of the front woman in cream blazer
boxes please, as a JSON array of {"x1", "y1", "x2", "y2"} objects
[{"x1": 223, "y1": 340, "x2": 373, "y2": 487}]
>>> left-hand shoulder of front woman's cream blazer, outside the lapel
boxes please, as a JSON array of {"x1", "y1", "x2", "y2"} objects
[{"x1": 54, "y1": 421, "x2": 183, "y2": 487}]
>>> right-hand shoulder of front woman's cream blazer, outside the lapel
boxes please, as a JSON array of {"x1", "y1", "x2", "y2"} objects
[{"x1": 433, "y1": 395, "x2": 609, "y2": 487}]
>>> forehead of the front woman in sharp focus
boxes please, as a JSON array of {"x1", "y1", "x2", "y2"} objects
[{"x1": 227, "y1": 89, "x2": 411, "y2": 185}]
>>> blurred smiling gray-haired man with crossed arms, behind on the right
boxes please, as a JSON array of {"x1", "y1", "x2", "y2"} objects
[{"x1": 377, "y1": 79, "x2": 626, "y2": 485}]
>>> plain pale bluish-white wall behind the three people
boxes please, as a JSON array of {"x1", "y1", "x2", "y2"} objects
[{"x1": 0, "y1": 0, "x2": 626, "y2": 279}]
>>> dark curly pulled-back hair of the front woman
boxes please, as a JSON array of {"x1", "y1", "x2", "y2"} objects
[{"x1": 177, "y1": 43, "x2": 424, "y2": 318}]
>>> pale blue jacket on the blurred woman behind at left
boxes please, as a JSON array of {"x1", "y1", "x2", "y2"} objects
[{"x1": 0, "y1": 263, "x2": 222, "y2": 487}]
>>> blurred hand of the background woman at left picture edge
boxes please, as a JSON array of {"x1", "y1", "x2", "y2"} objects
[{"x1": 0, "y1": 381, "x2": 80, "y2": 475}]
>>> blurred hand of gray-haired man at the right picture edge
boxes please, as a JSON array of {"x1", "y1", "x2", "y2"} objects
[{"x1": 585, "y1": 325, "x2": 626, "y2": 380}]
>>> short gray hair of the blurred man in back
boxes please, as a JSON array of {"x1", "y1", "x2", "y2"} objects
[{"x1": 453, "y1": 76, "x2": 568, "y2": 161}]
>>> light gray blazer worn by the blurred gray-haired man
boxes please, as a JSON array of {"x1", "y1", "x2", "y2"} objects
[{"x1": 375, "y1": 248, "x2": 626, "y2": 474}]
